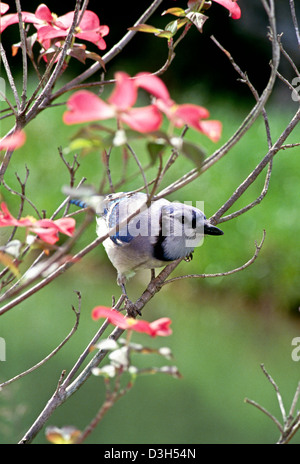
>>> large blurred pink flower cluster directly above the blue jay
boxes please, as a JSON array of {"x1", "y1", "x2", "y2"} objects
[{"x1": 63, "y1": 72, "x2": 222, "y2": 142}]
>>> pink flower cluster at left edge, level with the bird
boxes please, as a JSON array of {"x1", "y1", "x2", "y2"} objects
[{"x1": 0, "y1": 203, "x2": 75, "y2": 245}]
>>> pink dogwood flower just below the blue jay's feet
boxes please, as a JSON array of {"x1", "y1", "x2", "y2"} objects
[{"x1": 92, "y1": 306, "x2": 172, "y2": 337}]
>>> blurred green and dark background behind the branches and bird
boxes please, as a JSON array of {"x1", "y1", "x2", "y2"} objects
[{"x1": 0, "y1": 1, "x2": 300, "y2": 444}]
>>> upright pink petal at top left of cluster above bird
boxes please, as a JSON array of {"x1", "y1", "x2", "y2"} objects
[{"x1": 108, "y1": 72, "x2": 137, "y2": 110}]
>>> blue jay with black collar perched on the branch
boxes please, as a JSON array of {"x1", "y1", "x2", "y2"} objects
[{"x1": 70, "y1": 192, "x2": 223, "y2": 290}]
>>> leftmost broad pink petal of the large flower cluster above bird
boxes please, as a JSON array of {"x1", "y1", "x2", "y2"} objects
[{"x1": 63, "y1": 90, "x2": 115, "y2": 124}]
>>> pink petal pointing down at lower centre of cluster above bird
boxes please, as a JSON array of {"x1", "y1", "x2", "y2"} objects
[{"x1": 120, "y1": 105, "x2": 163, "y2": 133}]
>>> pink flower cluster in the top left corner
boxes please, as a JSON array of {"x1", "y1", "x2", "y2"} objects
[{"x1": 0, "y1": 3, "x2": 109, "y2": 50}]
